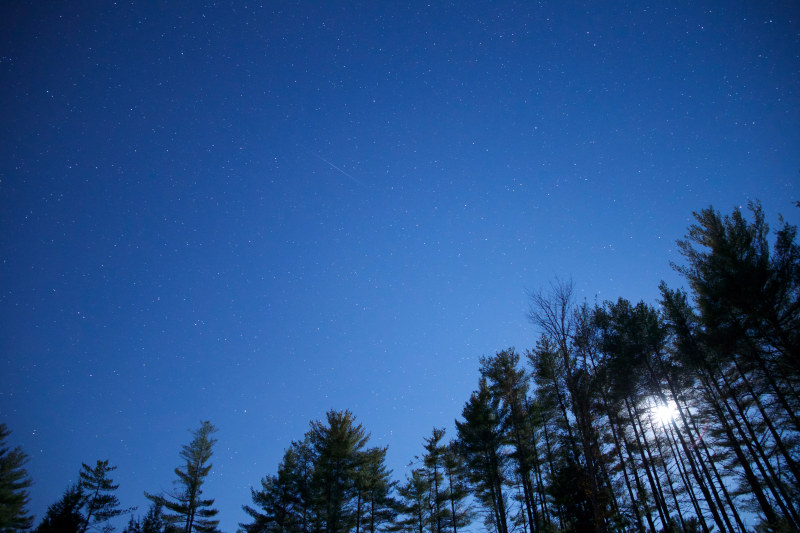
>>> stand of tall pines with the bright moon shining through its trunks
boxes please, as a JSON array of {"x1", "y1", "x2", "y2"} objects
[{"x1": 440, "y1": 204, "x2": 800, "y2": 533}]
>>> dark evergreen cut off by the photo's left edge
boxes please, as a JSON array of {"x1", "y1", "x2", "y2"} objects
[{"x1": 0, "y1": 424, "x2": 33, "y2": 532}]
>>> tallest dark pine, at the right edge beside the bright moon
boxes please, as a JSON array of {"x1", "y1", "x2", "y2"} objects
[{"x1": 662, "y1": 203, "x2": 800, "y2": 527}]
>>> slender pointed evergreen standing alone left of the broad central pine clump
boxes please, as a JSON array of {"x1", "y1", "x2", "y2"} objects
[{"x1": 145, "y1": 421, "x2": 219, "y2": 533}]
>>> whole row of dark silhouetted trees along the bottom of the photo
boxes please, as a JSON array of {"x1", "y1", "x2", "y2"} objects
[{"x1": 0, "y1": 204, "x2": 800, "y2": 533}]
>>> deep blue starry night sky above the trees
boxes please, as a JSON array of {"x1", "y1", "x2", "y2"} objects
[{"x1": 0, "y1": 0, "x2": 800, "y2": 531}]
